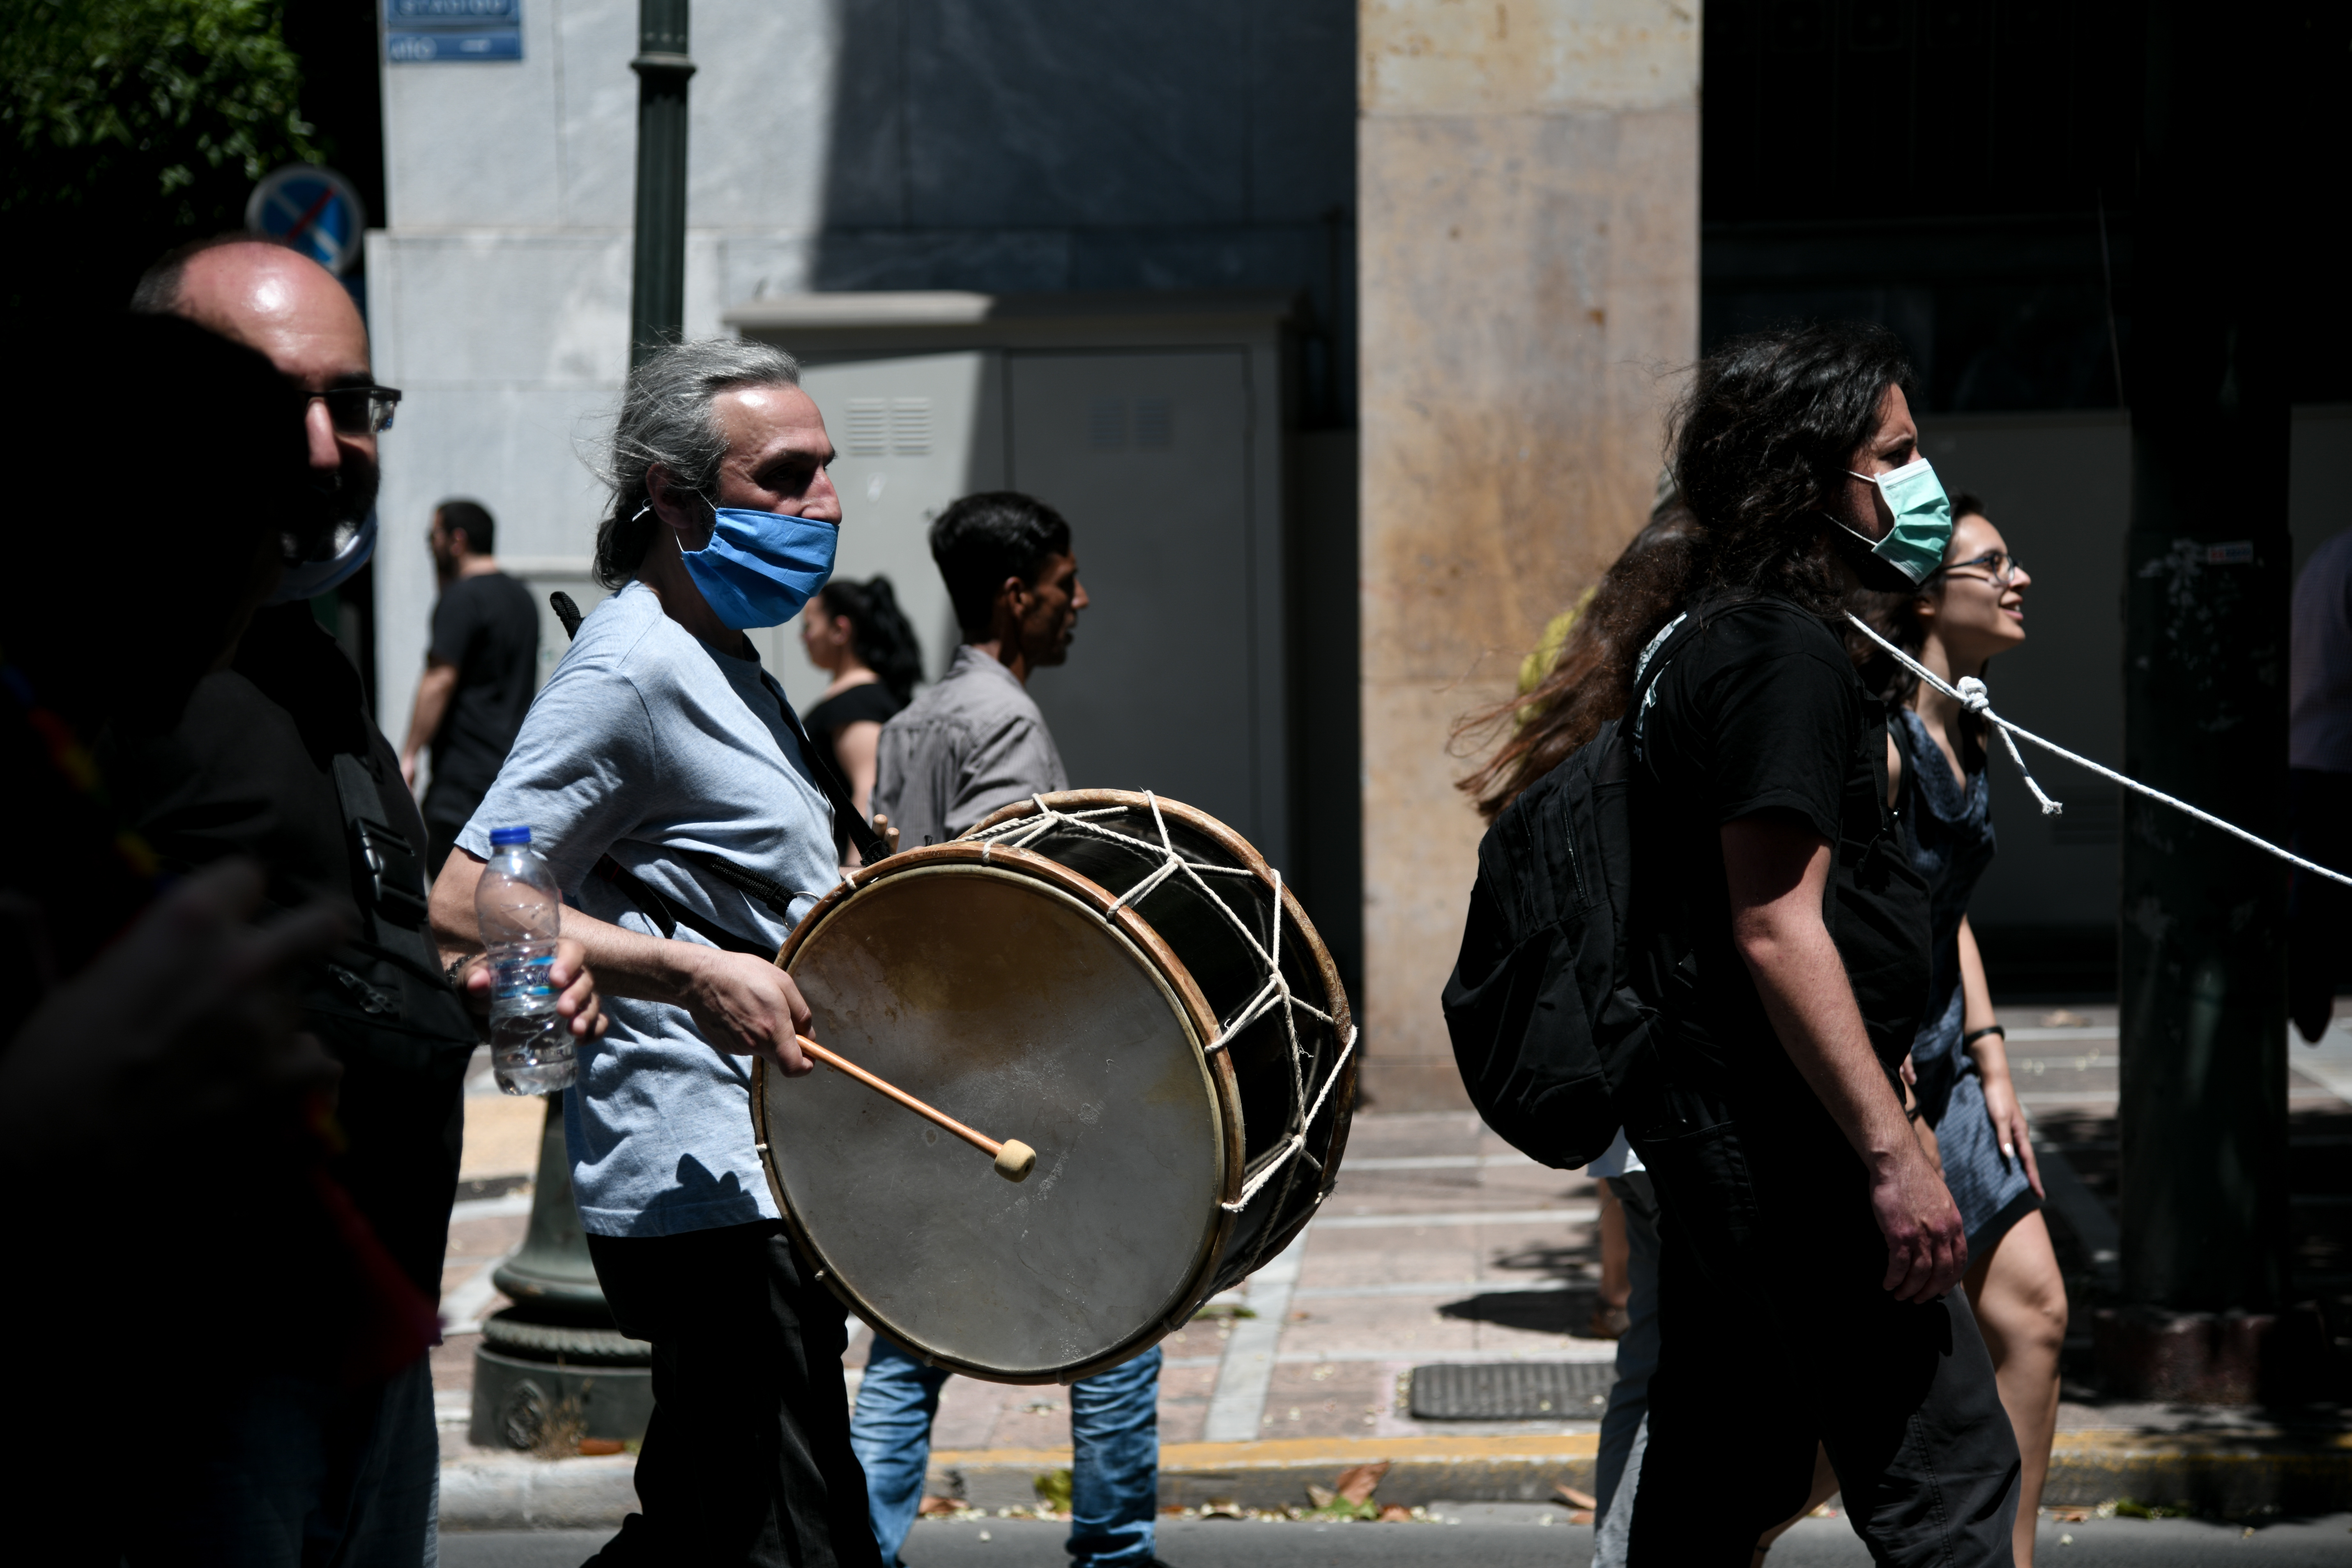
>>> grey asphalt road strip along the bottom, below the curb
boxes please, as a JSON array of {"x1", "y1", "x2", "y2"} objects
[{"x1": 440, "y1": 1502, "x2": 2352, "y2": 1568}]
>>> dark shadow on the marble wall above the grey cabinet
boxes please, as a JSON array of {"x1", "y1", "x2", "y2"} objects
[{"x1": 809, "y1": 0, "x2": 1355, "y2": 426}]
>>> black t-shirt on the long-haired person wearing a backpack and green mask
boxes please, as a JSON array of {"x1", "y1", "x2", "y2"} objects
[{"x1": 1630, "y1": 599, "x2": 1929, "y2": 1098}]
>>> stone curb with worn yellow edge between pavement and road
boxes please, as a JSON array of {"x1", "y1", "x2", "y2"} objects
[{"x1": 440, "y1": 1429, "x2": 2352, "y2": 1530}]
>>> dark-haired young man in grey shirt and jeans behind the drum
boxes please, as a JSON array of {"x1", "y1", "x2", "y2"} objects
[{"x1": 852, "y1": 491, "x2": 1160, "y2": 1568}]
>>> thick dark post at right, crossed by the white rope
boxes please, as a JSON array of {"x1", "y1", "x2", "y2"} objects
[{"x1": 2098, "y1": 0, "x2": 2317, "y2": 1403}]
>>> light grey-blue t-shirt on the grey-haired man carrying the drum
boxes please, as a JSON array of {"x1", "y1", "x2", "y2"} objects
[{"x1": 456, "y1": 583, "x2": 840, "y2": 1236}]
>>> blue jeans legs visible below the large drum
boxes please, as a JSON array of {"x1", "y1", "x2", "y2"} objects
[{"x1": 849, "y1": 1335, "x2": 1160, "y2": 1568}]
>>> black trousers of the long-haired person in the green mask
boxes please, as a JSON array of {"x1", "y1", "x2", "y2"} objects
[{"x1": 1627, "y1": 1103, "x2": 2018, "y2": 1568}]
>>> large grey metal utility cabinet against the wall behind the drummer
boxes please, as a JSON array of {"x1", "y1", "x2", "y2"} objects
[{"x1": 727, "y1": 292, "x2": 1298, "y2": 865}]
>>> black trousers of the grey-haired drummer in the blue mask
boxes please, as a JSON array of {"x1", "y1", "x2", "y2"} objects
[{"x1": 588, "y1": 1220, "x2": 882, "y2": 1568}]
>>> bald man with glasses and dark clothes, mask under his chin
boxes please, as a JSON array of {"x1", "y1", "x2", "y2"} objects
[{"x1": 108, "y1": 235, "x2": 602, "y2": 1568}]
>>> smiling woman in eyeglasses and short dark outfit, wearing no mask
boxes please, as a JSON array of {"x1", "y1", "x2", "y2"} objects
[{"x1": 1863, "y1": 494, "x2": 2067, "y2": 1568}]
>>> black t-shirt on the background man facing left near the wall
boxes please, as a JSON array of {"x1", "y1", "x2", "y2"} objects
[{"x1": 426, "y1": 571, "x2": 539, "y2": 825}]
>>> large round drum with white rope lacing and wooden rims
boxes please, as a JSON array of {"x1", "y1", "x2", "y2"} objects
[{"x1": 753, "y1": 790, "x2": 1355, "y2": 1382}]
